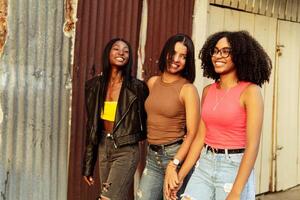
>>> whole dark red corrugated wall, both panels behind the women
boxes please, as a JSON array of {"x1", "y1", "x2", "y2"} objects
[{"x1": 68, "y1": 0, "x2": 194, "y2": 200}]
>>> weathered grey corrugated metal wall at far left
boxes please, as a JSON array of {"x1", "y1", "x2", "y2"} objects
[{"x1": 0, "y1": 0, "x2": 70, "y2": 200}]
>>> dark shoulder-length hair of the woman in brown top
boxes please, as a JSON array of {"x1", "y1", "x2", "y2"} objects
[{"x1": 159, "y1": 33, "x2": 195, "y2": 83}]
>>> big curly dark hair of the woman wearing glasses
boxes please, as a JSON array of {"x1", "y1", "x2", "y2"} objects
[{"x1": 199, "y1": 31, "x2": 272, "y2": 86}]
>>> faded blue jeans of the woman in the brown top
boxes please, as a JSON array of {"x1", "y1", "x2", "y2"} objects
[{"x1": 136, "y1": 144, "x2": 191, "y2": 200}]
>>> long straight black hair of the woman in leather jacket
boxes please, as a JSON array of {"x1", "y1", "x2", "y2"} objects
[{"x1": 99, "y1": 38, "x2": 133, "y2": 110}]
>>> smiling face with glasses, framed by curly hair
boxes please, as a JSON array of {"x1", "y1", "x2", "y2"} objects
[{"x1": 211, "y1": 37, "x2": 236, "y2": 75}]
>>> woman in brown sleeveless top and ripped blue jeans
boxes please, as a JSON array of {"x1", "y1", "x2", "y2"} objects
[{"x1": 136, "y1": 34, "x2": 200, "y2": 200}]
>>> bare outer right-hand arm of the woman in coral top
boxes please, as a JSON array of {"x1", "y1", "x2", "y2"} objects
[{"x1": 227, "y1": 85, "x2": 263, "y2": 200}]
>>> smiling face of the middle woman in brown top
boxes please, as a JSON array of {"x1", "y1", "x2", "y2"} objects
[{"x1": 166, "y1": 42, "x2": 187, "y2": 74}]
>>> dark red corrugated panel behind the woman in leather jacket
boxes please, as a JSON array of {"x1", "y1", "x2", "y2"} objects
[{"x1": 68, "y1": 0, "x2": 143, "y2": 200}]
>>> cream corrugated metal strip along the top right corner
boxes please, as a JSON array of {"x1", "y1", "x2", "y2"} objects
[{"x1": 210, "y1": 0, "x2": 300, "y2": 22}]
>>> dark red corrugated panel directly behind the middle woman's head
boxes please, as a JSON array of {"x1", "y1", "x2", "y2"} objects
[{"x1": 143, "y1": 0, "x2": 194, "y2": 80}]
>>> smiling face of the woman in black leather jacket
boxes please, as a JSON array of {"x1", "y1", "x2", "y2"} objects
[{"x1": 109, "y1": 40, "x2": 129, "y2": 67}]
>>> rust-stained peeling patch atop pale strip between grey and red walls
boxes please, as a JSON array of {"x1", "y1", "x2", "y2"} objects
[{"x1": 64, "y1": 0, "x2": 77, "y2": 37}]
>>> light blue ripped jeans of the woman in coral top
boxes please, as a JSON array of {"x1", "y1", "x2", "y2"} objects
[{"x1": 181, "y1": 147, "x2": 255, "y2": 200}]
